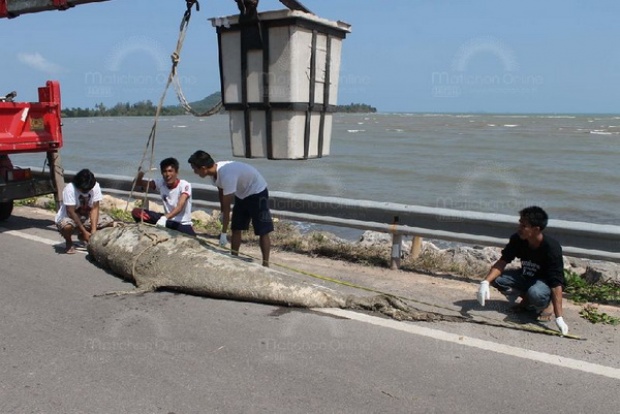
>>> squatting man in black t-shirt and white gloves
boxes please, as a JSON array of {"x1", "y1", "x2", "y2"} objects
[{"x1": 478, "y1": 206, "x2": 568, "y2": 335}]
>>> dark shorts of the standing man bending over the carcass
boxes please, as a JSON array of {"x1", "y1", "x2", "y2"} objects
[{"x1": 230, "y1": 188, "x2": 273, "y2": 236}]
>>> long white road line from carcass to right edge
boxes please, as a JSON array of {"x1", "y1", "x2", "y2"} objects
[{"x1": 313, "y1": 309, "x2": 620, "y2": 379}]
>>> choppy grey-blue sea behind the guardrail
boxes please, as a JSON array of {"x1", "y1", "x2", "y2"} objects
[{"x1": 12, "y1": 113, "x2": 620, "y2": 230}]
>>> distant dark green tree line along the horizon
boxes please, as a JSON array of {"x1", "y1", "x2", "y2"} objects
[{"x1": 62, "y1": 92, "x2": 377, "y2": 118}]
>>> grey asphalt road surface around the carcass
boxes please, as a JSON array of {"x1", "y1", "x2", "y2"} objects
[{"x1": 0, "y1": 207, "x2": 620, "y2": 414}]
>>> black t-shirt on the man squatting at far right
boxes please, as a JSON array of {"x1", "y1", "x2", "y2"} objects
[{"x1": 501, "y1": 233, "x2": 566, "y2": 288}]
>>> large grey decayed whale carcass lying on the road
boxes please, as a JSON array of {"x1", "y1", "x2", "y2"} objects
[{"x1": 88, "y1": 223, "x2": 462, "y2": 321}]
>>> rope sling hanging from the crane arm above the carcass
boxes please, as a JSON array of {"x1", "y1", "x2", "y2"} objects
[{"x1": 125, "y1": 0, "x2": 222, "y2": 212}]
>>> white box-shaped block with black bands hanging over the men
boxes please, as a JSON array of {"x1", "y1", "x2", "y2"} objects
[{"x1": 211, "y1": 10, "x2": 351, "y2": 160}]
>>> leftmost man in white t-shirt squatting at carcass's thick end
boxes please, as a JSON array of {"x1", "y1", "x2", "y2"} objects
[{"x1": 55, "y1": 169, "x2": 114, "y2": 254}]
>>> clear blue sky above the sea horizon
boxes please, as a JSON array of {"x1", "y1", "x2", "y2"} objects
[{"x1": 0, "y1": 0, "x2": 620, "y2": 114}]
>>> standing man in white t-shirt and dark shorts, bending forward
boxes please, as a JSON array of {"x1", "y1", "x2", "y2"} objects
[{"x1": 188, "y1": 151, "x2": 273, "y2": 267}]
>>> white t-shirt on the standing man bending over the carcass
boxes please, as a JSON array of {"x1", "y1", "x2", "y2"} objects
[{"x1": 212, "y1": 161, "x2": 267, "y2": 200}]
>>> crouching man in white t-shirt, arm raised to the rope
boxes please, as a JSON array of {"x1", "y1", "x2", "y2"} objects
[{"x1": 131, "y1": 157, "x2": 196, "y2": 236}]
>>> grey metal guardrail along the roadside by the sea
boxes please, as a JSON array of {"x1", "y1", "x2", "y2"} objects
[{"x1": 54, "y1": 171, "x2": 620, "y2": 266}]
